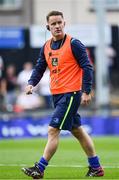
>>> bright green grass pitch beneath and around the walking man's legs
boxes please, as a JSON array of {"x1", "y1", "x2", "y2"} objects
[{"x1": 0, "y1": 137, "x2": 119, "y2": 180}]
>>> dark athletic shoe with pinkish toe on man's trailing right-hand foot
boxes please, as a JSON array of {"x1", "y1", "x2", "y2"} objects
[{"x1": 86, "y1": 166, "x2": 104, "y2": 177}]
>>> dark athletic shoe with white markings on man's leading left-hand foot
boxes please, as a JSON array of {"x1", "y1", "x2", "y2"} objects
[{"x1": 22, "y1": 163, "x2": 44, "y2": 179}]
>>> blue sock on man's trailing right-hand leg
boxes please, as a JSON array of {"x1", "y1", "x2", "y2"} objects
[{"x1": 88, "y1": 156, "x2": 100, "y2": 168}]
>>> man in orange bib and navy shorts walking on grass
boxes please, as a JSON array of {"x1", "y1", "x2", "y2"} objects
[{"x1": 22, "y1": 11, "x2": 104, "y2": 179}]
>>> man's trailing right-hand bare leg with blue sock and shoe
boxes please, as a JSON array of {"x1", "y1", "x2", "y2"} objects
[{"x1": 72, "y1": 126, "x2": 104, "y2": 176}]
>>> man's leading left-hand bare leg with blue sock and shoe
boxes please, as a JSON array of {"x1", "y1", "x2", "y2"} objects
[{"x1": 22, "y1": 126, "x2": 60, "y2": 179}]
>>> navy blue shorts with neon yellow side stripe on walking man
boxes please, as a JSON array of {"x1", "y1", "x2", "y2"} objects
[{"x1": 49, "y1": 91, "x2": 82, "y2": 131}]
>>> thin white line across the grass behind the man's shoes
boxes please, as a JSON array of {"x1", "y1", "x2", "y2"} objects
[{"x1": 0, "y1": 164, "x2": 119, "y2": 169}]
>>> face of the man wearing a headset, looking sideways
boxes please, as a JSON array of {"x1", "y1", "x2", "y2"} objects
[{"x1": 48, "y1": 15, "x2": 65, "y2": 39}]
